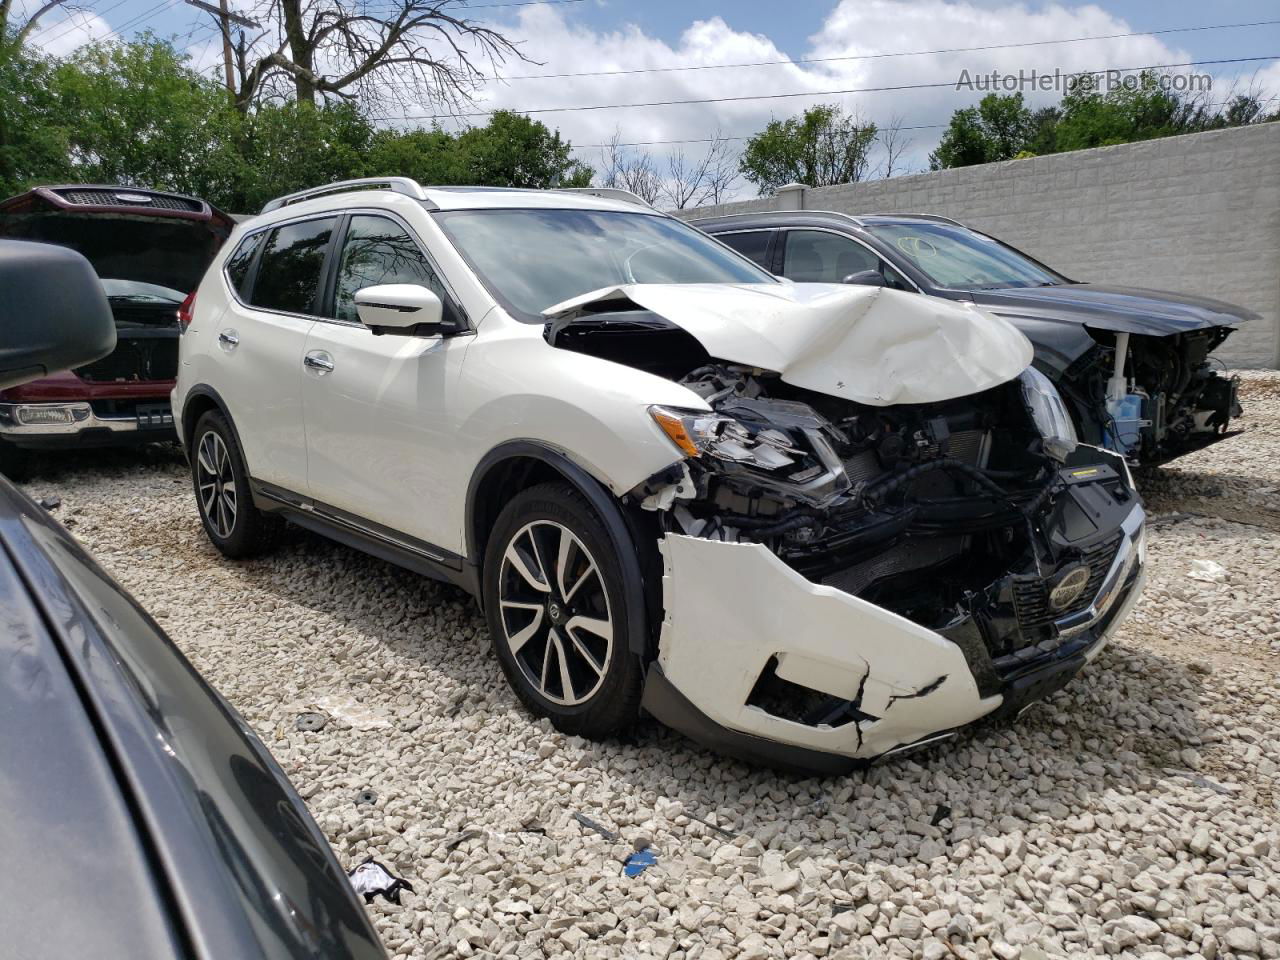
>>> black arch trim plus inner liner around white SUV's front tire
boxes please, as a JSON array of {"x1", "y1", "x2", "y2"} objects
[{"x1": 465, "y1": 440, "x2": 662, "y2": 659}]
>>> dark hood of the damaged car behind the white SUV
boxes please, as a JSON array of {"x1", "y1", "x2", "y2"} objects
[{"x1": 973, "y1": 283, "x2": 1258, "y2": 337}]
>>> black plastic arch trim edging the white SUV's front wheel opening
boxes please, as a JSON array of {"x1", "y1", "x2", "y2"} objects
[{"x1": 466, "y1": 440, "x2": 652, "y2": 658}]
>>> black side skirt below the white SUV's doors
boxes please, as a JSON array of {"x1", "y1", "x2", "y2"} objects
[{"x1": 250, "y1": 479, "x2": 480, "y2": 596}]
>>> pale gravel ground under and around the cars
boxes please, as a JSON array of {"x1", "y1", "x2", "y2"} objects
[{"x1": 17, "y1": 374, "x2": 1280, "y2": 960}]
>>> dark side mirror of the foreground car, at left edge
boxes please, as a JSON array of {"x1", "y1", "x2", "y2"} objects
[{"x1": 0, "y1": 241, "x2": 115, "y2": 389}]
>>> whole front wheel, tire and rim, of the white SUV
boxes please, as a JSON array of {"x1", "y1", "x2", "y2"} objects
[{"x1": 481, "y1": 484, "x2": 643, "y2": 740}]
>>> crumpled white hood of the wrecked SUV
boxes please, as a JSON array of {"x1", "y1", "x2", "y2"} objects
[{"x1": 543, "y1": 283, "x2": 1032, "y2": 407}]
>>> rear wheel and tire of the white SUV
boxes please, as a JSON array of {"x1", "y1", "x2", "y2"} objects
[{"x1": 191, "y1": 410, "x2": 283, "y2": 559}]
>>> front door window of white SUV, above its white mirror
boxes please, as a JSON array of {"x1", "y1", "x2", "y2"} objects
[{"x1": 333, "y1": 215, "x2": 456, "y2": 323}]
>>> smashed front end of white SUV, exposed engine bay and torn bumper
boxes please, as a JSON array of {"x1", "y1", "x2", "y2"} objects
[{"x1": 545, "y1": 293, "x2": 1143, "y2": 767}]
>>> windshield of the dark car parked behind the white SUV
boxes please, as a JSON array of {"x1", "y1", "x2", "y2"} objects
[{"x1": 867, "y1": 223, "x2": 1068, "y2": 291}]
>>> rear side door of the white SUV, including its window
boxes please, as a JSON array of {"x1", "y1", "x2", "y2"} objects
[{"x1": 216, "y1": 215, "x2": 338, "y2": 494}]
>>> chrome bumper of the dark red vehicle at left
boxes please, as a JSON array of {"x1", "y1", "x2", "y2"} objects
[{"x1": 0, "y1": 398, "x2": 177, "y2": 449}]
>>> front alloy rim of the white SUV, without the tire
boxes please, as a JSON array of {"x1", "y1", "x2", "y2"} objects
[{"x1": 498, "y1": 520, "x2": 613, "y2": 707}]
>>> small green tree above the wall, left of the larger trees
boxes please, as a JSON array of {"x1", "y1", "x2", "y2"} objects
[{"x1": 740, "y1": 104, "x2": 876, "y2": 195}]
